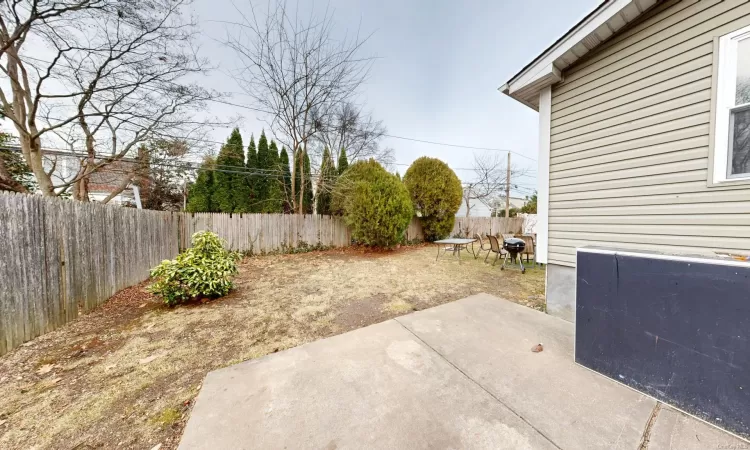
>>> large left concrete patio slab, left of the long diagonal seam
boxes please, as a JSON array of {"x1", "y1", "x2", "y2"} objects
[{"x1": 180, "y1": 321, "x2": 555, "y2": 449}]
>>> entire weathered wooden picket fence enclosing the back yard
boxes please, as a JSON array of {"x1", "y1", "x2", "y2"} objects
[{"x1": 0, "y1": 192, "x2": 523, "y2": 355}]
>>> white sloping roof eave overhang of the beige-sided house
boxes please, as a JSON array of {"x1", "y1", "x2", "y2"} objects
[{"x1": 498, "y1": 0, "x2": 659, "y2": 110}]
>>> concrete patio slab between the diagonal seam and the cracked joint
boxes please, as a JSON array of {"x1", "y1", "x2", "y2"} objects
[{"x1": 396, "y1": 295, "x2": 656, "y2": 449}]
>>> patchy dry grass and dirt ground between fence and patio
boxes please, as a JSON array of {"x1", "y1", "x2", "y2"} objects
[{"x1": 0, "y1": 246, "x2": 544, "y2": 450}]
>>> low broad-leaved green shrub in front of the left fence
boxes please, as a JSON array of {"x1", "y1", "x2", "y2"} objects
[{"x1": 149, "y1": 231, "x2": 240, "y2": 306}]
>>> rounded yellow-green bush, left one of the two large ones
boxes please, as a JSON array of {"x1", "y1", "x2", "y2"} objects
[{"x1": 333, "y1": 160, "x2": 414, "y2": 247}]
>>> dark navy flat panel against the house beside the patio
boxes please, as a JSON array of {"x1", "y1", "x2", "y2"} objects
[{"x1": 575, "y1": 250, "x2": 750, "y2": 437}]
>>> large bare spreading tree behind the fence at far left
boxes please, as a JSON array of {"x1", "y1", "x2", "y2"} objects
[{"x1": 0, "y1": 0, "x2": 216, "y2": 201}]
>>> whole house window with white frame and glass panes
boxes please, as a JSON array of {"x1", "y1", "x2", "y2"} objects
[{"x1": 714, "y1": 27, "x2": 750, "y2": 182}]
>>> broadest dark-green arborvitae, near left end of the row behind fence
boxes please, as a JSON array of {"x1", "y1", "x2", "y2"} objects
[{"x1": 212, "y1": 128, "x2": 250, "y2": 213}]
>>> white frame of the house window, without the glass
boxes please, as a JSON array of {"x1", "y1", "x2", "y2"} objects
[{"x1": 712, "y1": 26, "x2": 750, "y2": 184}]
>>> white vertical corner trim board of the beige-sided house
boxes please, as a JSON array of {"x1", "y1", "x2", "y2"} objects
[{"x1": 536, "y1": 86, "x2": 552, "y2": 264}]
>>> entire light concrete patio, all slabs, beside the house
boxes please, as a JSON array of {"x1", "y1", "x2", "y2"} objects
[{"x1": 180, "y1": 294, "x2": 747, "y2": 450}]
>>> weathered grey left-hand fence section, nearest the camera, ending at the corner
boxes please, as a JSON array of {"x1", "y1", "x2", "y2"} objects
[{"x1": 0, "y1": 193, "x2": 178, "y2": 355}]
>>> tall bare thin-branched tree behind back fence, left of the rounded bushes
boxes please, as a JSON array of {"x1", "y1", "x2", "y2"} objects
[{"x1": 226, "y1": 1, "x2": 372, "y2": 213}]
